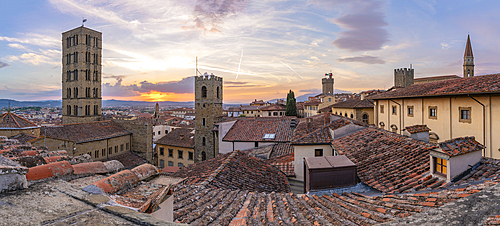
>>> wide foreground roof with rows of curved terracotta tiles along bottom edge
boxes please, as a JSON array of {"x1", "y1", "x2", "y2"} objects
[{"x1": 174, "y1": 181, "x2": 498, "y2": 225}]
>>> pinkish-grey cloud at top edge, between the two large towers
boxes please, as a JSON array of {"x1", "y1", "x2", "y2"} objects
[{"x1": 184, "y1": 0, "x2": 249, "y2": 33}]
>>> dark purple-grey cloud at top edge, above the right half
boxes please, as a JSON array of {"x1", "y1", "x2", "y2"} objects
[{"x1": 313, "y1": 0, "x2": 389, "y2": 52}]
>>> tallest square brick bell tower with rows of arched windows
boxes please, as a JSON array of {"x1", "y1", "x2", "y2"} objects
[{"x1": 62, "y1": 26, "x2": 102, "y2": 124}]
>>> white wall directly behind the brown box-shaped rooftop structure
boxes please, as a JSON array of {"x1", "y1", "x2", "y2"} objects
[{"x1": 293, "y1": 145, "x2": 333, "y2": 181}]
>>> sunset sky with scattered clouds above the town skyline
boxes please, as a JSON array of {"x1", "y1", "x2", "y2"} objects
[{"x1": 0, "y1": 0, "x2": 500, "y2": 103}]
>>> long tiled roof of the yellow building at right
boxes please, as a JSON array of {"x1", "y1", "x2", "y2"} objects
[{"x1": 368, "y1": 74, "x2": 500, "y2": 99}]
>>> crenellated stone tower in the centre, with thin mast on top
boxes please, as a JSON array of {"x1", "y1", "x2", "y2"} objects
[{"x1": 194, "y1": 72, "x2": 222, "y2": 162}]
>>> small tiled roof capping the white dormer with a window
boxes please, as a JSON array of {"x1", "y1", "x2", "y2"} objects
[{"x1": 439, "y1": 137, "x2": 485, "y2": 156}]
